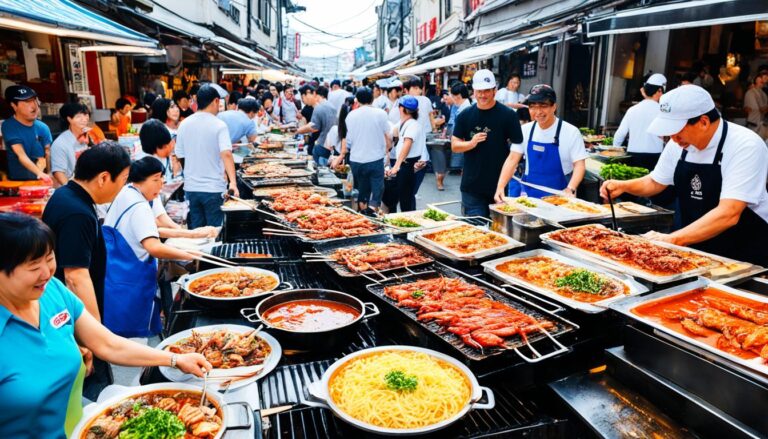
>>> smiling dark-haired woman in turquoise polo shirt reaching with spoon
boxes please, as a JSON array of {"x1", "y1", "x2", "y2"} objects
[{"x1": 0, "y1": 213, "x2": 212, "y2": 439}]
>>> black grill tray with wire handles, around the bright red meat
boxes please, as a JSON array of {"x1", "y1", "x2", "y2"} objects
[{"x1": 366, "y1": 262, "x2": 579, "y2": 363}]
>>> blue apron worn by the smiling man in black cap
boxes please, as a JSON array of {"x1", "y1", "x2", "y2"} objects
[{"x1": 508, "y1": 119, "x2": 568, "y2": 198}]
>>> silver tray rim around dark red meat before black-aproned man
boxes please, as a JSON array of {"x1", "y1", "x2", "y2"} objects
[{"x1": 541, "y1": 224, "x2": 711, "y2": 284}]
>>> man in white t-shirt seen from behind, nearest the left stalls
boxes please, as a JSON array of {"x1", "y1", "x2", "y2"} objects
[{"x1": 176, "y1": 84, "x2": 240, "y2": 228}]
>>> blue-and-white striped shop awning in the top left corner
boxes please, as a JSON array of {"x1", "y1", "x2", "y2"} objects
[{"x1": 0, "y1": 0, "x2": 157, "y2": 47}]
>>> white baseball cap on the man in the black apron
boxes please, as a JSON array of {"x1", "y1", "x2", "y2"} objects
[{"x1": 648, "y1": 84, "x2": 715, "y2": 136}]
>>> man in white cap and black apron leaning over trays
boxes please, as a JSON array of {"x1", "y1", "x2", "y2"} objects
[{"x1": 600, "y1": 85, "x2": 768, "y2": 266}]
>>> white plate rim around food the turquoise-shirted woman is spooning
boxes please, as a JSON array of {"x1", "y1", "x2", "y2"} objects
[{"x1": 156, "y1": 324, "x2": 283, "y2": 390}]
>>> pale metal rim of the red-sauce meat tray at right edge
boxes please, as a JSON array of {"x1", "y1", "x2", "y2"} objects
[{"x1": 609, "y1": 277, "x2": 768, "y2": 375}]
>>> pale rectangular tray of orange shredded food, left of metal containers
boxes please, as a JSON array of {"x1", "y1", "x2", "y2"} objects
[{"x1": 408, "y1": 223, "x2": 524, "y2": 260}]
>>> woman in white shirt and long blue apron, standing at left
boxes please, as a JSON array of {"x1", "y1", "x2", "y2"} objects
[{"x1": 103, "y1": 157, "x2": 194, "y2": 338}]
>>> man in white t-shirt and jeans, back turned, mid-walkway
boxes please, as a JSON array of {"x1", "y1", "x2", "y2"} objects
[{"x1": 341, "y1": 87, "x2": 392, "y2": 214}]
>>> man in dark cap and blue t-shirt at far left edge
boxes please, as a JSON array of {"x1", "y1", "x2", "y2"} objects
[{"x1": 2, "y1": 85, "x2": 53, "y2": 184}]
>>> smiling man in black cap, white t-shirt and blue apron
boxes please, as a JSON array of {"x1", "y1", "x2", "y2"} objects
[{"x1": 494, "y1": 84, "x2": 589, "y2": 202}]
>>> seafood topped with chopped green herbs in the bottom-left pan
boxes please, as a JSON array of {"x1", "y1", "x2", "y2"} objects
[{"x1": 80, "y1": 390, "x2": 222, "y2": 439}]
